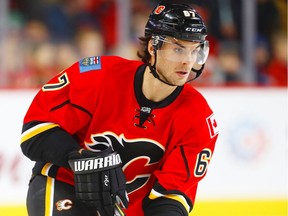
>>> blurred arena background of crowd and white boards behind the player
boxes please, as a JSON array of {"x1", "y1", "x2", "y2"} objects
[{"x1": 0, "y1": 0, "x2": 288, "y2": 216}]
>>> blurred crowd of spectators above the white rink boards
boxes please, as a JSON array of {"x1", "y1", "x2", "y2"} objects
[{"x1": 0, "y1": 0, "x2": 287, "y2": 88}]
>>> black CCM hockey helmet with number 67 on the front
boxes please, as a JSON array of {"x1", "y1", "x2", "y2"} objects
[{"x1": 145, "y1": 1, "x2": 207, "y2": 42}]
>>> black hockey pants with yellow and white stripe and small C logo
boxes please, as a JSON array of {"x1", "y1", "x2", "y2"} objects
[{"x1": 26, "y1": 175, "x2": 97, "y2": 216}]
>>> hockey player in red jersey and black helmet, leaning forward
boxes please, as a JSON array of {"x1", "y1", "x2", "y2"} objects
[{"x1": 21, "y1": 1, "x2": 218, "y2": 216}]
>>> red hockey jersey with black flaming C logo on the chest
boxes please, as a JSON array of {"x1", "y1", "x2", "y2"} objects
[{"x1": 22, "y1": 56, "x2": 218, "y2": 216}]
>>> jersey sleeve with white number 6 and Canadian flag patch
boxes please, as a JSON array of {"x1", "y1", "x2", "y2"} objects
[{"x1": 143, "y1": 106, "x2": 218, "y2": 215}]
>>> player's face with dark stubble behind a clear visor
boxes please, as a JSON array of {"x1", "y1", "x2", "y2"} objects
[{"x1": 156, "y1": 38, "x2": 200, "y2": 86}]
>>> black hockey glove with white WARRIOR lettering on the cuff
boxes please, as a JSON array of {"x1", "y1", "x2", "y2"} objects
[{"x1": 68, "y1": 147, "x2": 128, "y2": 216}]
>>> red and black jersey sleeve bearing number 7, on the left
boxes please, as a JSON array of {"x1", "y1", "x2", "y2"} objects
[{"x1": 21, "y1": 56, "x2": 101, "y2": 167}]
